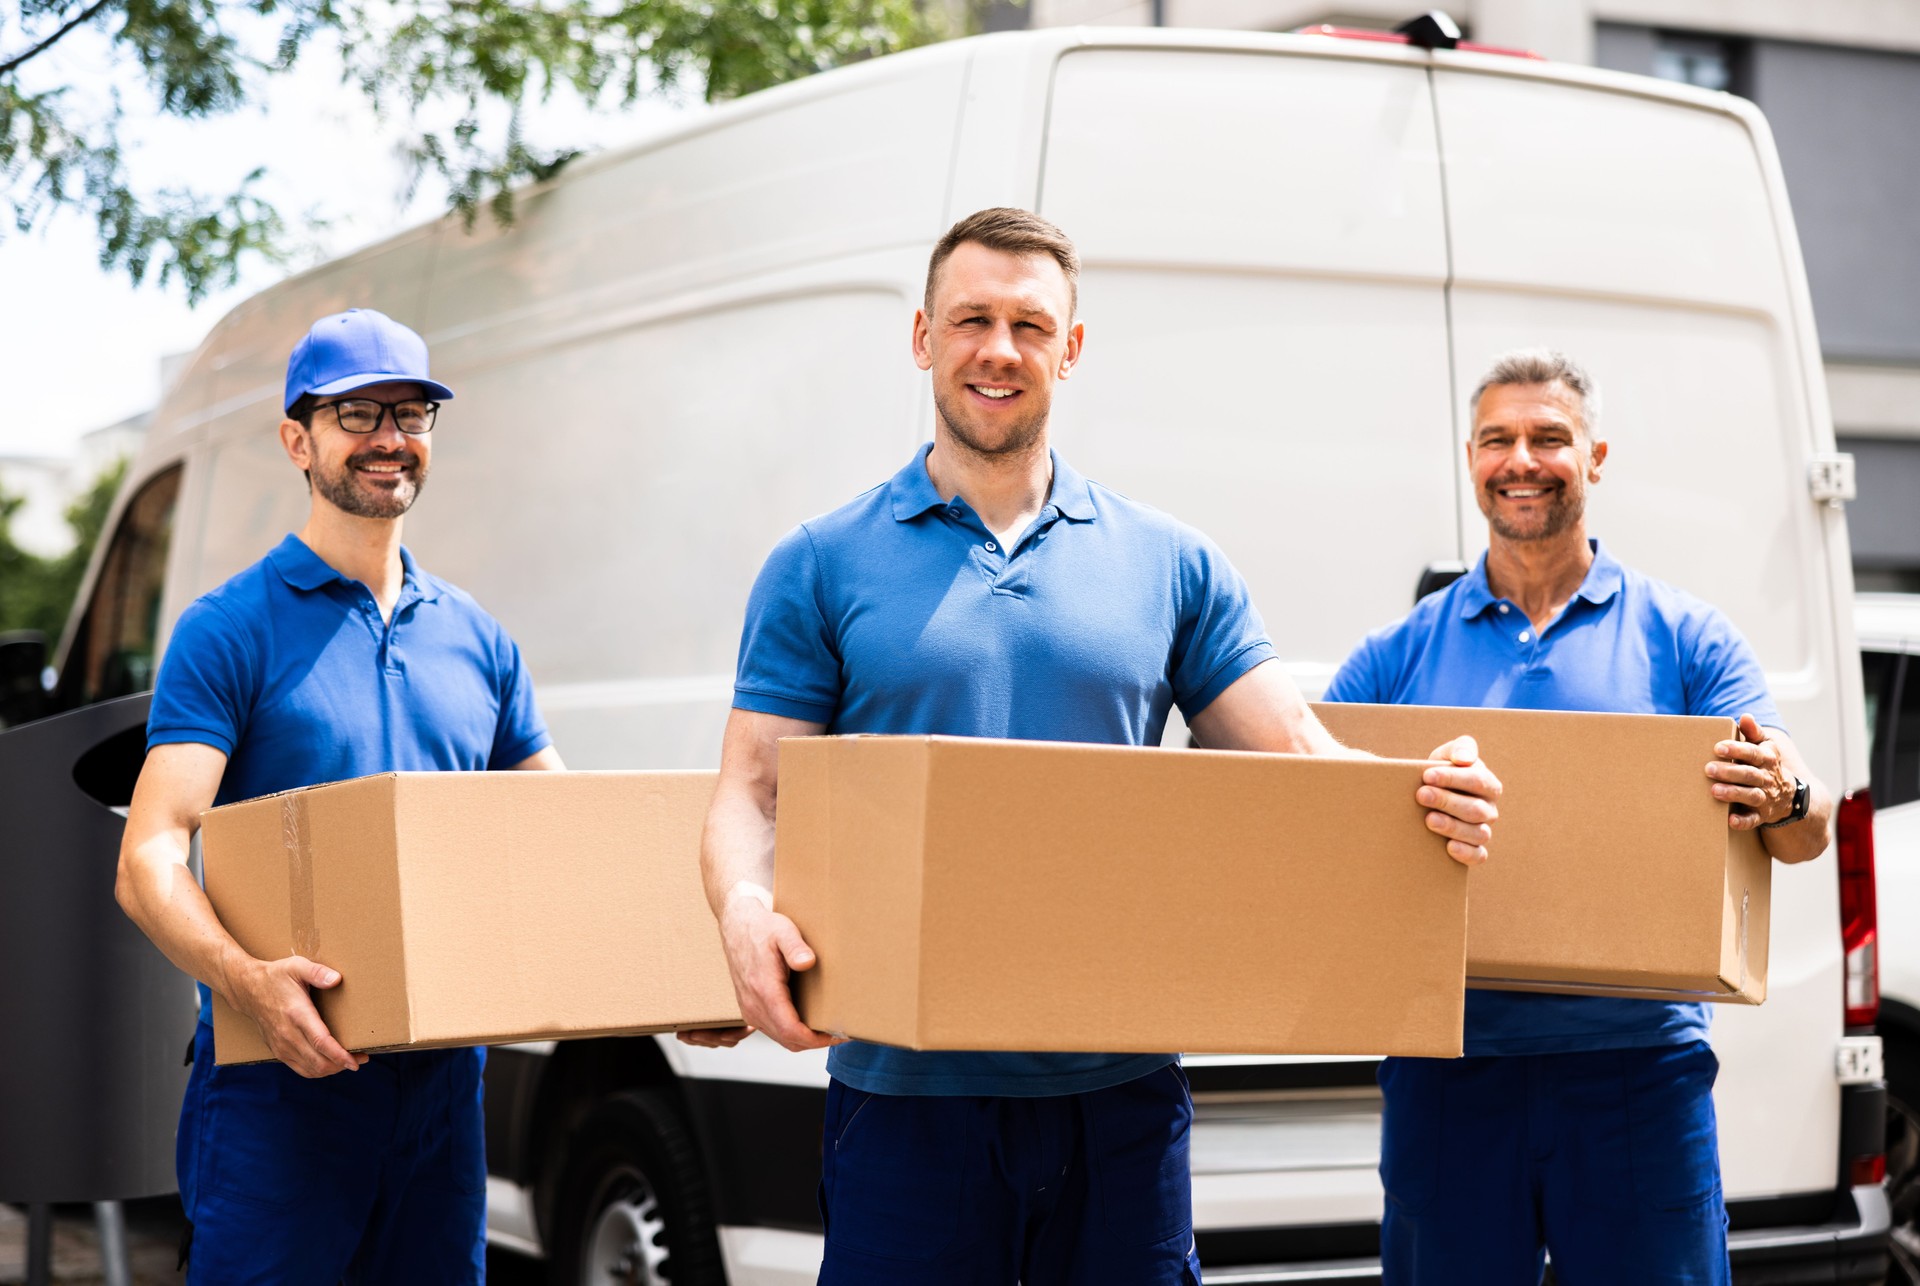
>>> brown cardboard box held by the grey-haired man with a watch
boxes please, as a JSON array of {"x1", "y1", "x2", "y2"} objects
[{"x1": 1315, "y1": 704, "x2": 1772, "y2": 1004}]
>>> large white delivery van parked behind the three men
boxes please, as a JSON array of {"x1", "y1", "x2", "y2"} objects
[{"x1": 30, "y1": 29, "x2": 1889, "y2": 1286}]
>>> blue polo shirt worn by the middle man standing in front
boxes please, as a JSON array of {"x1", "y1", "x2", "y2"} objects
[{"x1": 733, "y1": 447, "x2": 1273, "y2": 1096}]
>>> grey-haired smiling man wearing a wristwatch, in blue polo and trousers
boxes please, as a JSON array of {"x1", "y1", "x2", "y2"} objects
[{"x1": 1327, "y1": 349, "x2": 1834, "y2": 1286}]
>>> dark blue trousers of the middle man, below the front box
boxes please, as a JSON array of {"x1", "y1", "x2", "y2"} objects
[{"x1": 820, "y1": 1065, "x2": 1200, "y2": 1286}]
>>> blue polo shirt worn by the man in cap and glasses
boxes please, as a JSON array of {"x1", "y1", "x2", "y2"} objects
[{"x1": 146, "y1": 536, "x2": 551, "y2": 1021}]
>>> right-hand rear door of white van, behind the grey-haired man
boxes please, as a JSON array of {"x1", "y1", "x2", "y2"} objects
[{"x1": 1434, "y1": 71, "x2": 1845, "y2": 1198}]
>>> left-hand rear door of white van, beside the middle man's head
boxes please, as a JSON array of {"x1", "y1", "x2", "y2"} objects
[{"x1": 1041, "y1": 48, "x2": 1459, "y2": 689}]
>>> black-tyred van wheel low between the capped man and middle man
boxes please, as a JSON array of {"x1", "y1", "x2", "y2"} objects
[{"x1": 549, "y1": 1088, "x2": 726, "y2": 1286}]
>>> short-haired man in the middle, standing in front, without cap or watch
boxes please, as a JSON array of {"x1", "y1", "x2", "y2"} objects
[{"x1": 682, "y1": 209, "x2": 1500, "y2": 1286}]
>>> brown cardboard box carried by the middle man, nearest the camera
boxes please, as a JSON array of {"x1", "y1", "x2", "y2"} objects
[{"x1": 776, "y1": 737, "x2": 1467, "y2": 1058}]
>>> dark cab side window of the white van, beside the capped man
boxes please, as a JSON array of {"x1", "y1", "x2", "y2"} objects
[{"x1": 54, "y1": 464, "x2": 180, "y2": 710}]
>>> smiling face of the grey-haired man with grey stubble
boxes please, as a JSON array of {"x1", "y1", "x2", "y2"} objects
[{"x1": 1467, "y1": 380, "x2": 1607, "y2": 541}]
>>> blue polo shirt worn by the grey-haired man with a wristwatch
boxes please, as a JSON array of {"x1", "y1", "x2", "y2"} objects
[{"x1": 1327, "y1": 539, "x2": 1780, "y2": 1056}]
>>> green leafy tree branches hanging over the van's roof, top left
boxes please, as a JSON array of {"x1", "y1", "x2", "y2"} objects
[{"x1": 0, "y1": 0, "x2": 952, "y2": 301}]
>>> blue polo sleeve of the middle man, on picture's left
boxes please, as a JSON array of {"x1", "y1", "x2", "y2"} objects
[{"x1": 733, "y1": 526, "x2": 841, "y2": 724}]
